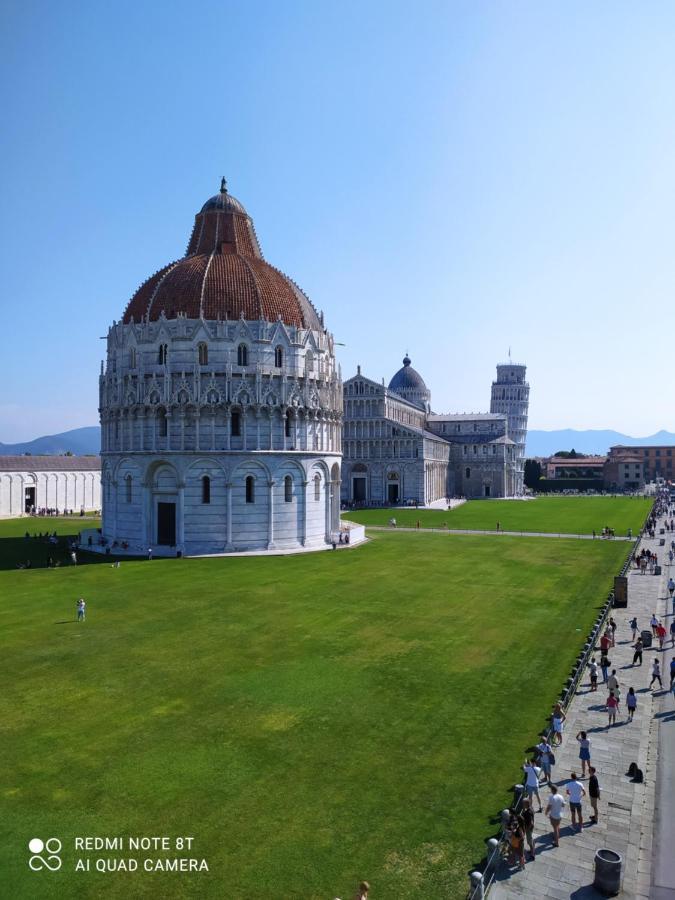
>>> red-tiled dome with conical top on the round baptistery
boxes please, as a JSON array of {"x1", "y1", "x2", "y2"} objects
[{"x1": 123, "y1": 183, "x2": 323, "y2": 331}]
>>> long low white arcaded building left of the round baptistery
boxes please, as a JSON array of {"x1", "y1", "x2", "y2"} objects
[{"x1": 0, "y1": 456, "x2": 101, "y2": 517}]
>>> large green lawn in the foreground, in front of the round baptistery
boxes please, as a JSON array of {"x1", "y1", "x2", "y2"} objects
[{"x1": 0, "y1": 522, "x2": 627, "y2": 900}]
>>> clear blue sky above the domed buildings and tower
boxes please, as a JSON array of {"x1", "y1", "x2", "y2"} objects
[{"x1": 0, "y1": 0, "x2": 675, "y2": 442}]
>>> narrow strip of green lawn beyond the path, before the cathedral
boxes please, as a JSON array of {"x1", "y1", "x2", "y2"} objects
[{"x1": 343, "y1": 497, "x2": 652, "y2": 537}]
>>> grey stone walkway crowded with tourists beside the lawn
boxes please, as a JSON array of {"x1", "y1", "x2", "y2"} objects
[{"x1": 489, "y1": 528, "x2": 673, "y2": 900}]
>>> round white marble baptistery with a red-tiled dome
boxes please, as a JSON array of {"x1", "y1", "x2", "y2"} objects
[{"x1": 100, "y1": 179, "x2": 342, "y2": 555}]
